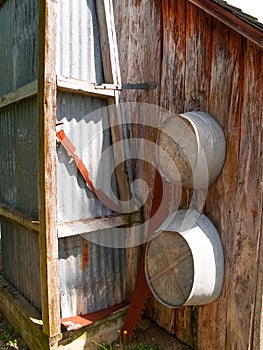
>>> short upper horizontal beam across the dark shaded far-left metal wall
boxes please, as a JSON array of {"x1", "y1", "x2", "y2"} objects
[{"x1": 0, "y1": 80, "x2": 37, "y2": 109}]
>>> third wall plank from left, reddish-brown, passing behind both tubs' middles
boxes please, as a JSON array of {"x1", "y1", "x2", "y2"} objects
[{"x1": 174, "y1": 1, "x2": 216, "y2": 347}]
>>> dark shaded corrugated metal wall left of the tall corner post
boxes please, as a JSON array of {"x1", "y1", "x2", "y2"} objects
[{"x1": 0, "y1": 0, "x2": 41, "y2": 310}]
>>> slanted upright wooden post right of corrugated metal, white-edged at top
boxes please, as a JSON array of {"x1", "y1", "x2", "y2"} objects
[{"x1": 96, "y1": 0, "x2": 138, "y2": 298}]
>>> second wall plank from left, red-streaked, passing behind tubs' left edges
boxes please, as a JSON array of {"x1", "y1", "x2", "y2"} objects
[{"x1": 147, "y1": 0, "x2": 188, "y2": 332}]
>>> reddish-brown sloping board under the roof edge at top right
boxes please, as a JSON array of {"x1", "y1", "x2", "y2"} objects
[{"x1": 188, "y1": 0, "x2": 263, "y2": 47}]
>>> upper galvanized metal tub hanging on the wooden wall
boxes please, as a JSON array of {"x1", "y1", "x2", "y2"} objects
[{"x1": 157, "y1": 112, "x2": 226, "y2": 189}]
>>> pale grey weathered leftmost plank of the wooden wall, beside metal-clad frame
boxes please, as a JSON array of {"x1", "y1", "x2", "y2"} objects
[{"x1": 113, "y1": 0, "x2": 161, "y2": 299}]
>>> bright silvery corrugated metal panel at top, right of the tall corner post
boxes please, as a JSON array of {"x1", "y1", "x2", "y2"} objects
[{"x1": 57, "y1": 0, "x2": 103, "y2": 83}]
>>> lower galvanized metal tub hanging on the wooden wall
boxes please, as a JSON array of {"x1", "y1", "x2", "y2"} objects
[{"x1": 145, "y1": 210, "x2": 224, "y2": 308}]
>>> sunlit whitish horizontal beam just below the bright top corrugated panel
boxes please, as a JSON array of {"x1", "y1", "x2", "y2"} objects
[{"x1": 57, "y1": 76, "x2": 118, "y2": 98}]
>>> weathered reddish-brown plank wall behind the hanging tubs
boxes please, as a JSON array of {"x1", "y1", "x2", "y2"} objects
[{"x1": 114, "y1": 0, "x2": 263, "y2": 350}]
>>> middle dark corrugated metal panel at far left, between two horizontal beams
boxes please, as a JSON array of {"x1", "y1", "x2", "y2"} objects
[{"x1": 0, "y1": 98, "x2": 38, "y2": 218}]
